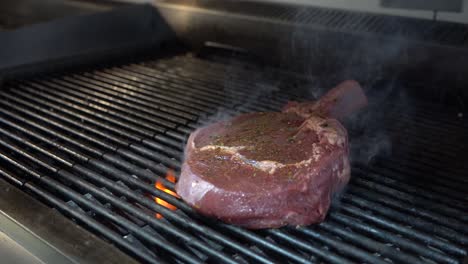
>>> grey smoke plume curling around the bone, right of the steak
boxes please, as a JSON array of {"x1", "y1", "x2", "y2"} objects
[{"x1": 284, "y1": 9, "x2": 420, "y2": 167}]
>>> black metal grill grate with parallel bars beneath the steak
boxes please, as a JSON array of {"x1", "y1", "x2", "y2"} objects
[{"x1": 0, "y1": 52, "x2": 468, "y2": 263}]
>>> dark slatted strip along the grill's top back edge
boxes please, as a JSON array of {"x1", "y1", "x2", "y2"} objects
[{"x1": 171, "y1": 0, "x2": 468, "y2": 46}]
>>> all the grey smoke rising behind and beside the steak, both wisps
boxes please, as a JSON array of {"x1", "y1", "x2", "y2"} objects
[{"x1": 194, "y1": 6, "x2": 413, "y2": 169}]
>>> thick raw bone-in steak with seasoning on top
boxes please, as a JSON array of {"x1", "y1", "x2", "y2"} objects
[{"x1": 176, "y1": 81, "x2": 367, "y2": 229}]
